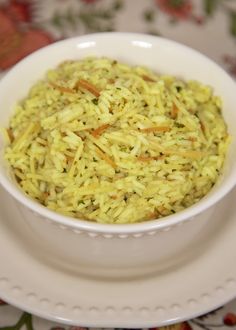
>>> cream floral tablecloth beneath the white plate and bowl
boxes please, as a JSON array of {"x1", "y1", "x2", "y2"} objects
[{"x1": 0, "y1": 0, "x2": 236, "y2": 330}]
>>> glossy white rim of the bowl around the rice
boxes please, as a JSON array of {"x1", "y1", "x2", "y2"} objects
[{"x1": 0, "y1": 32, "x2": 236, "y2": 234}]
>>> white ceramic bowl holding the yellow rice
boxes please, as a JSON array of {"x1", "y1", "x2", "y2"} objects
[{"x1": 0, "y1": 33, "x2": 236, "y2": 277}]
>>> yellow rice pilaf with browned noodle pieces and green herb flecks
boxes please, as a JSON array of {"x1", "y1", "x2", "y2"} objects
[{"x1": 5, "y1": 58, "x2": 229, "y2": 223}]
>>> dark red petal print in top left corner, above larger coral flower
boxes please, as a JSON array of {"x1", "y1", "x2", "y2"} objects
[{"x1": 5, "y1": 0, "x2": 32, "y2": 22}]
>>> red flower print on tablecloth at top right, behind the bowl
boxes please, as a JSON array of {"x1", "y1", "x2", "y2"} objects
[{"x1": 155, "y1": 0, "x2": 193, "y2": 20}]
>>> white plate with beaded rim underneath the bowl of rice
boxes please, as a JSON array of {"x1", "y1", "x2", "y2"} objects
[{"x1": 0, "y1": 189, "x2": 236, "y2": 328}]
